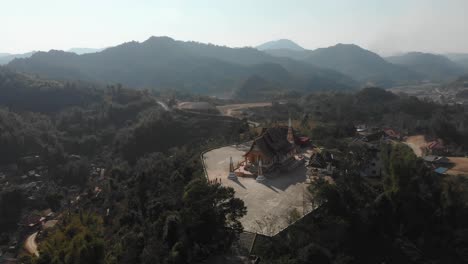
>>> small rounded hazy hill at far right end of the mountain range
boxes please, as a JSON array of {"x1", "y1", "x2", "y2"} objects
[{"x1": 386, "y1": 52, "x2": 465, "y2": 82}]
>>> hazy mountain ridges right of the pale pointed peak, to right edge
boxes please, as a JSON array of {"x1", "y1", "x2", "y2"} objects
[{"x1": 264, "y1": 39, "x2": 468, "y2": 87}]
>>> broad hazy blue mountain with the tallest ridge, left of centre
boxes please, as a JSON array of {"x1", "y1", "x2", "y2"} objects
[{"x1": 8, "y1": 37, "x2": 357, "y2": 94}]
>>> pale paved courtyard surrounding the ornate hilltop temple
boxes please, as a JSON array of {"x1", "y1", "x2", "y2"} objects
[{"x1": 203, "y1": 144, "x2": 311, "y2": 236}]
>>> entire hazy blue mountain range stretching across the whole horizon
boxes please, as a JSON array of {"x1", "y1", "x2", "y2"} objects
[{"x1": 6, "y1": 37, "x2": 468, "y2": 97}]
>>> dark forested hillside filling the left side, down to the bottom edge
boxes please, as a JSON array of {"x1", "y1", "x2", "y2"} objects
[{"x1": 0, "y1": 69, "x2": 248, "y2": 264}]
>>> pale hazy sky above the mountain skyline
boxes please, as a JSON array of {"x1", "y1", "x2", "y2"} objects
[{"x1": 0, "y1": 0, "x2": 468, "y2": 54}]
